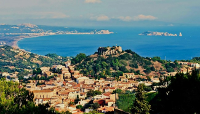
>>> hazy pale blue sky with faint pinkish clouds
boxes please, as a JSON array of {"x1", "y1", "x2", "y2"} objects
[{"x1": 0, "y1": 0, "x2": 200, "y2": 26}]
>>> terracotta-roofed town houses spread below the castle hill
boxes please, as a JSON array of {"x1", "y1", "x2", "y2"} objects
[{"x1": 1, "y1": 61, "x2": 200, "y2": 114}]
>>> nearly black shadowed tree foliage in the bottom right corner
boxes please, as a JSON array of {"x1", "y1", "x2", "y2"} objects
[{"x1": 149, "y1": 70, "x2": 200, "y2": 114}]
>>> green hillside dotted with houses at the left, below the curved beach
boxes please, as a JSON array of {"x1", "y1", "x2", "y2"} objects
[{"x1": 0, "y1": 46, "x2": 68, "y2": 73}]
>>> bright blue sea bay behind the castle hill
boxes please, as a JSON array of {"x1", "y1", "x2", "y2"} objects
[{"x1": 18, "y1": 26, "x2": 200, "y2": 61}]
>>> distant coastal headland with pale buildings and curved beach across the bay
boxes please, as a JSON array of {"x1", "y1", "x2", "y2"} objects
[{"x1": 0, "y1": 23, "x2": 114, "y2": 48}]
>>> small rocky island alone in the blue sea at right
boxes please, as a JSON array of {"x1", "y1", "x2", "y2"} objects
[{"x1": 139, "y1": 31, "x2": 182, "y2": 36}]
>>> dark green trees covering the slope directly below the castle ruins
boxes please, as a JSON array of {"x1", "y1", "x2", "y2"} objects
[{"x1": 72, "y1": 50, "x2": 155, "y2": 78}]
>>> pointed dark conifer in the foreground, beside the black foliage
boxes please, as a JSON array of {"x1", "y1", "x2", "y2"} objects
[{"x1": 132, "y1": 84, "x2": 151, "y2": 114}]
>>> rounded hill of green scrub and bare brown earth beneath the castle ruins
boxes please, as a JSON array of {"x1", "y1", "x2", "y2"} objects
[{"x1": 72, "y1": 47, "x2": 180, "y2": 78}]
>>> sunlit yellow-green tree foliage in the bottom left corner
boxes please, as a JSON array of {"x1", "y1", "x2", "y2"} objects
[{"x1": 0, "y1": 79, "x2": 65, "y2": 114}]
